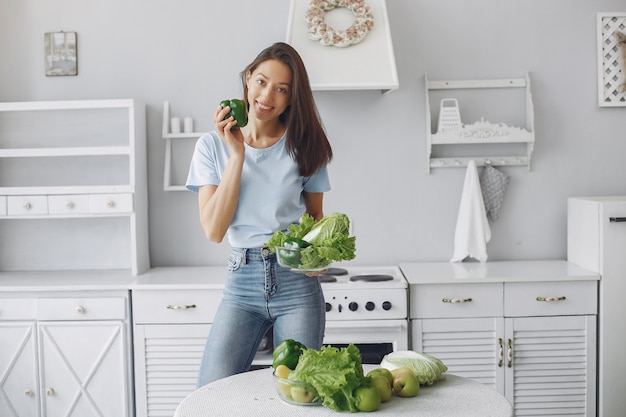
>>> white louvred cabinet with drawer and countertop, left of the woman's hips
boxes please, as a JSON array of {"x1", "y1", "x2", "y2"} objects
[{"x1": 131, "y1": 267, "x2": 226, "y2": 417}]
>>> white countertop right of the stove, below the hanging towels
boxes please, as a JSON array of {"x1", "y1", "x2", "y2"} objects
[{"x1": 400, "y1": 260, "x2": 600, "y2": 284}]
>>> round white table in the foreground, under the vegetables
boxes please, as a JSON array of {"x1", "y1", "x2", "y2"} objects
[{"x1": 174, "y1": 365, "x2": 513, "y2": 417}]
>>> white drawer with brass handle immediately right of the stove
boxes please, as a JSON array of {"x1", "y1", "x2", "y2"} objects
[{"x1": 411, "y1": 283, "x2": 503, "y2": 318}]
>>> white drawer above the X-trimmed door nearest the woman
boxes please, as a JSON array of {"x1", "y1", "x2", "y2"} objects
[{"x1": 37, "y1": 297, "x2": 127, "y2": 320}]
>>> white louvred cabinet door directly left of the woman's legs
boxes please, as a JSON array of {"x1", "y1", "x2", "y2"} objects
[{"x1": 134, "y1": 324, "x2": 211, "y2": 417}]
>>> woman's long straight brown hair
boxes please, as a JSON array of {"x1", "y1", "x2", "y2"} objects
[{"x1": 240, "y1": 42, "x2": 333, "y2": 177}]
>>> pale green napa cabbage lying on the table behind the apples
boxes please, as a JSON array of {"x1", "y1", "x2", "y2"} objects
[{"x1": 380, "y1": 350, "x2": 448, "y2": 385}]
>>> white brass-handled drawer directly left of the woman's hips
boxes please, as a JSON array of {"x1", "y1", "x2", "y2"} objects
[{"x1": 133, "y1": 289, "x2": 222, "y2": 324}]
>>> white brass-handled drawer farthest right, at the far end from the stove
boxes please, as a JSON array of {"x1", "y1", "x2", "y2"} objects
[{"x1": 504, "y1": 281, "x2": 598, "y2": 317}]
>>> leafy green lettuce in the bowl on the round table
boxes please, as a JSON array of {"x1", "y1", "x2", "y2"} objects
[{"x1": 288, "y1": 344, "x2": 368, "y2": 412}]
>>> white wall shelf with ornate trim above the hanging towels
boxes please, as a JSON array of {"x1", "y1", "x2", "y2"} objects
[{"x1": 424, "y1": 74, "x2": 535, "y2": 173}]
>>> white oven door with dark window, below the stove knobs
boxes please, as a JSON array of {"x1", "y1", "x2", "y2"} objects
[{"x1": 324, "y1": 320, "x2": 409, "y2": 365}]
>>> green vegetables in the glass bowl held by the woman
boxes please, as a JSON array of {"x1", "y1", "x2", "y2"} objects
[{"x1": 265, "y1": 213, "x2": 356, "y2": 270}]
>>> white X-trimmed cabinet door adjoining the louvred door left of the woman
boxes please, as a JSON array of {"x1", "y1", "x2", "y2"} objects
[{"x1": 37, "y1": 321, "x2": 130, "y2": 417}]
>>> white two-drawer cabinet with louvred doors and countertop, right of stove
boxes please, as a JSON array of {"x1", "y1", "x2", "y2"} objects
[{"x1": 401, "y1": 262, "x2": 597, "y2": 416}]
